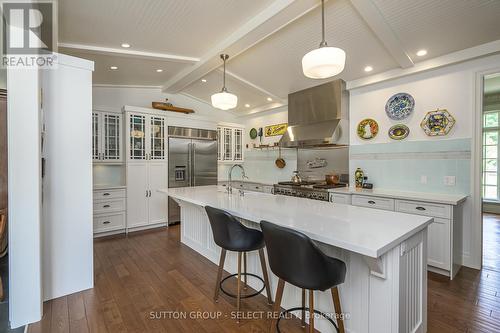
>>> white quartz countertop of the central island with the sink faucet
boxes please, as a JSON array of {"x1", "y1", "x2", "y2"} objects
[{"x1": 159, "y1": 185, "x2": 433, "y2": 258}]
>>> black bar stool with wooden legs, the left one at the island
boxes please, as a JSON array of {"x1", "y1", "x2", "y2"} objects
[{"x1": 205, "y1": 206, "x2": 273, "y2": 322}]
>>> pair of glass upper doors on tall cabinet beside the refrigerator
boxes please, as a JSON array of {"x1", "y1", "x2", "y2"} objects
[{"x1": 126, "y1": 113, "x2": 166, "y2": 161}]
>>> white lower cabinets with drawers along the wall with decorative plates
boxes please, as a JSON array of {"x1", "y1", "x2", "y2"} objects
[{"x1": 330, "y1": 189, "x2": 463, "y2": 279}]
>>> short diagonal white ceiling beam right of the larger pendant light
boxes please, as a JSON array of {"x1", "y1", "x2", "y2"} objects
[{"x1": 351, "y1": 0, "x2": 414, "y2": 68}]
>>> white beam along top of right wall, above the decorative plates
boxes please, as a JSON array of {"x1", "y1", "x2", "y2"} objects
[{"x1": 346, "y1": 40, "x2": 500, "y2": 90}]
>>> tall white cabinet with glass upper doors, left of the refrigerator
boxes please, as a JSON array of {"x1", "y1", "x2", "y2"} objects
[{"x1": 125, "y1": 112, "x2": 168, "y2": 231}]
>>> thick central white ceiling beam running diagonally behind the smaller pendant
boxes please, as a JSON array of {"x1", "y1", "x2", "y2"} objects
[{"x1": 163, "y1": 0, "x2": 320, "y2": 93}]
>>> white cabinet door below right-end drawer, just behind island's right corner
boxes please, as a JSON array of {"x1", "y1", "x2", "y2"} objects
[{"x1": 427, "y1": 218, "x2": 451, "y2": 270}]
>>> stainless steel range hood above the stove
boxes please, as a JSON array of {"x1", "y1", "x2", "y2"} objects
[{"x1": 279, "y1": 80, "x2": 349, "y2": 148}]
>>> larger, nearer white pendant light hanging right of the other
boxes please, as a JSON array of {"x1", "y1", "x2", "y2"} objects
[{"x1": 302, "y1": 0, "x2": 346, "y2": 79}]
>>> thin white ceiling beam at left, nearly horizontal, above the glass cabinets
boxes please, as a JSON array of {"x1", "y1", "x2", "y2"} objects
[{"x1": 58, "y1": 43, "x2": 200, "y2": 64}]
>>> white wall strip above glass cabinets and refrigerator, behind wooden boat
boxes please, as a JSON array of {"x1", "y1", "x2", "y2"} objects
[{"x1": 92, "y1": 85, "x2": 240, "y2": 122}]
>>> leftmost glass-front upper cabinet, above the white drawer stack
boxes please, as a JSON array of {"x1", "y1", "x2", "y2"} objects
[{"x1": 92, "y1": 111, "x2": 123, "y2": 163}]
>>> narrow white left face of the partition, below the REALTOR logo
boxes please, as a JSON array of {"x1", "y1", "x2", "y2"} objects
[{"x1": 7, "y1": 69, "x2": 42, "y2": 328}]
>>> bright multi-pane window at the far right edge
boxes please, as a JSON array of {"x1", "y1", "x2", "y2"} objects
[{"x1": 483, "y1": 110, "x2": 500, "y2": 201}]
